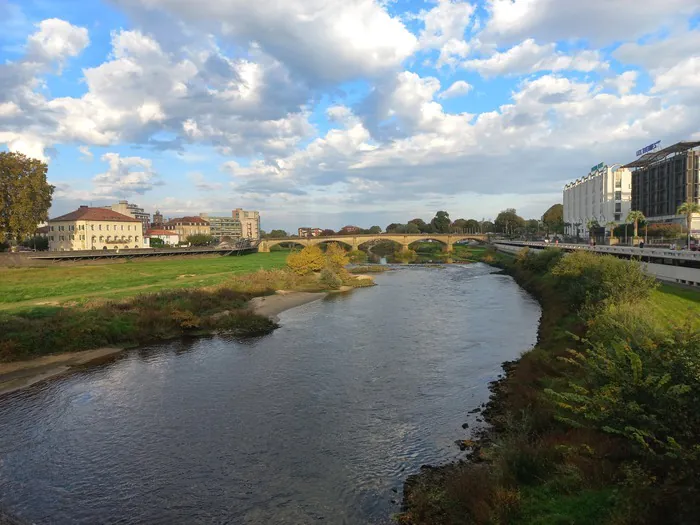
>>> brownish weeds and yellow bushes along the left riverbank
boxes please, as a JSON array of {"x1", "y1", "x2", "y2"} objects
[{"x1": 0, "y1": 248, "x2": 373, "y2": 361}]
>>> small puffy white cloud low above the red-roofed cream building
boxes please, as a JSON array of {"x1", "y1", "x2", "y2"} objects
[{"x1": 92, "y1": 153, "x2": 163, "y2": 198}]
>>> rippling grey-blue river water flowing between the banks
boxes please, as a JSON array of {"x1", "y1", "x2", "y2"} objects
[{"x1": 0, "y1": 264, "x2": 540, "y2": 525}]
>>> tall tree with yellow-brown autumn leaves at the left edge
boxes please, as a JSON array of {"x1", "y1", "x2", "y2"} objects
[{"x1": 0, "y1": 151, "x2": 54, "y2": 241}]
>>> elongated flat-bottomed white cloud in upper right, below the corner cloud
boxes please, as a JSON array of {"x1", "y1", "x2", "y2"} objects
[{"x1": 462, "y1": 38, "x2": 608, "y2": 77}]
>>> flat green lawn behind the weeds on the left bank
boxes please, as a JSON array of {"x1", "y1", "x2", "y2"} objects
[{"x1": 0, "y1": 252, "x2": 287, "y2": 310}]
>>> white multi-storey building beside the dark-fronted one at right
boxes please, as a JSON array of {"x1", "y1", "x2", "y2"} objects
[{"x1": 564, "y1": 163, "x2": 632, "y2": 237}]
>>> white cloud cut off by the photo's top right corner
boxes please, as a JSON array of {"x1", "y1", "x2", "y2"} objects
[{"x1": 484, "y1": 0, "x2": 700, "y2": 44}]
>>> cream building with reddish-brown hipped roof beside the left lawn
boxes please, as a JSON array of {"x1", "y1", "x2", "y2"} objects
[{"x1": 49, "y1": 206, "x2": 144, "y2": 251}]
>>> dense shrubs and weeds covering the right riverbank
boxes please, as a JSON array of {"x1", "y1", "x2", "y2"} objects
[{"x1": 399, "y1": 249, "x2": 700, "y2": 525}]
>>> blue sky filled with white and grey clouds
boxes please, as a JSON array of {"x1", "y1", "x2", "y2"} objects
[{"x1": 0, "y1": 0, "x2": 700, "y2": 230}]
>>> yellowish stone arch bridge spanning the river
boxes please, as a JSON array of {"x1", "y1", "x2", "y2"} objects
[{"x1": 258, "y1": 233, "x2": 488, "y2": 253}]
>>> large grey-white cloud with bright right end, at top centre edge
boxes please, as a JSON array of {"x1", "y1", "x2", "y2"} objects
[{"x1": 110, "y1": 0, "x2": 417, "y2": 83}]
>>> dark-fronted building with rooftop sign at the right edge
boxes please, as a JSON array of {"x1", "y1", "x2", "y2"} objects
[{"x1": 625, "y1": 141, "x2": 700, "y2": 235}]
